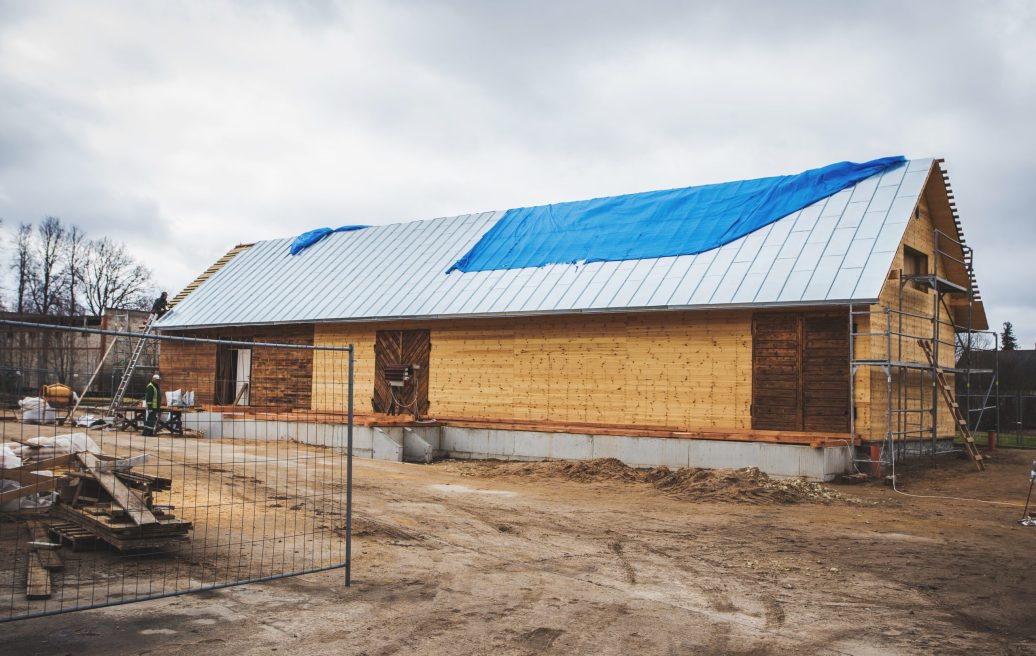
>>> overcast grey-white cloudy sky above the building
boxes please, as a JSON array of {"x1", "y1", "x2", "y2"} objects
[{"x1": 0, "y1": 0, "x2": 1036, "y2": 347}]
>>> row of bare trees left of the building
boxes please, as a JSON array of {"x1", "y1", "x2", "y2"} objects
[{"x1": 0, "y1": 217, "x2": 154, "y2": 316}]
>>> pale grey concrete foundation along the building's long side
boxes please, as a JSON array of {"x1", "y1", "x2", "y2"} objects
[{"x1": 183, "y1": 412, "x2": 853, "y2": 481}]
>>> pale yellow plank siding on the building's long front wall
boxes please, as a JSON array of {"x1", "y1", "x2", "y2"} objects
[{"x1": 313, "y1": 312, "x2": 751, "y2": 430}]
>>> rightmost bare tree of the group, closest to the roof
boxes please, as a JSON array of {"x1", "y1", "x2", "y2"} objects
[{"x1": 81, "y1": 237, "x2": 152, "y2": 314}]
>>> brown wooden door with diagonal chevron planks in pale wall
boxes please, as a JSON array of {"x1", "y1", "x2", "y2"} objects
[{"x1": 371, "y1": 331, "x2": 432, "y2": 416}]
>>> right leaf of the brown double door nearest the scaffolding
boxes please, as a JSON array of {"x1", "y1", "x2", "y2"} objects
[{"x1": 802, "y1": 315, "x2": 850, "y2": 433}]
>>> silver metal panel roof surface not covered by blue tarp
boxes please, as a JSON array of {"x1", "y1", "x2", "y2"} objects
[{"x1": 157, "y1": 160, "x2": 932, "y2": 329}]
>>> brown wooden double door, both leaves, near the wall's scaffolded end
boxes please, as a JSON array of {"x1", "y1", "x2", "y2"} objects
[{"x1": 752, "y1": 312, "x2": 850, "y2": 433}]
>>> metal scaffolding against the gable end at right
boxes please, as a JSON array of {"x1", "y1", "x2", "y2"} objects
[{"x1": 848, "y1": 224, "x2": 1000, "y2": 472}]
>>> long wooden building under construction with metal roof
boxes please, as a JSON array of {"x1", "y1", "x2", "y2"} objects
[{"x1": 157, "y1": 158, "x2": 992, "y2": 480}]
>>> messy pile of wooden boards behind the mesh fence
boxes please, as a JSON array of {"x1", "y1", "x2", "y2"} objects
[{"x1": 0, "y1": 449, "x2": 192, "y2": 599}]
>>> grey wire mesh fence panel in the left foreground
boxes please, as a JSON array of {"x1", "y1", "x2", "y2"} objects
[{"x1": 0, "y1": 321, "x2": 352, "y2": 621}]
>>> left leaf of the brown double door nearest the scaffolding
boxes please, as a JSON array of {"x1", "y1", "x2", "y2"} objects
[{"x1": 752, "y1": 313, "x2": 802, "y2": 430}]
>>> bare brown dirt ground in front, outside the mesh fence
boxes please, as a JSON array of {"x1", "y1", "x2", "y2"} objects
[{"x1": 0, "y1": 429, "x2": 1036, "y2": 656}]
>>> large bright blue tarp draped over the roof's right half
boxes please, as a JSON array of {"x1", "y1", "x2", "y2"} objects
[{"x1": 450, "y1": 156, "x2": 905, "y2": 272}]
